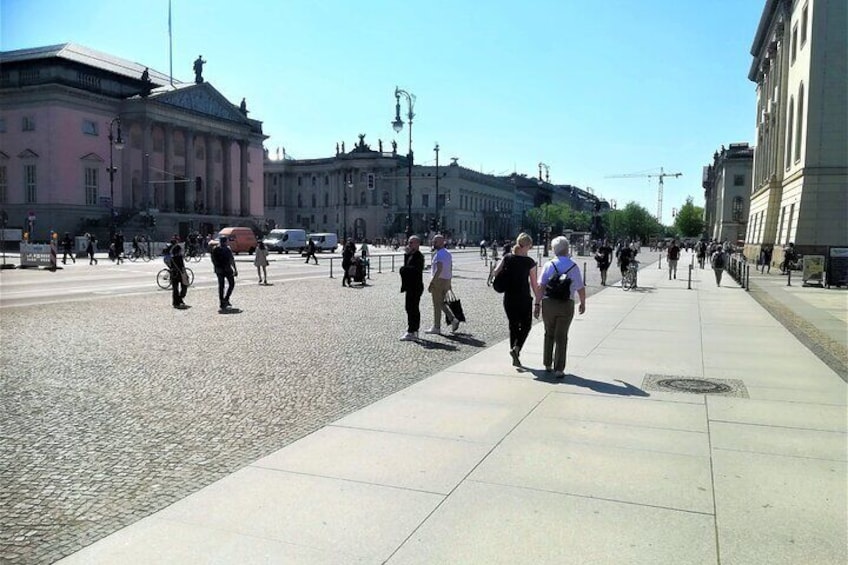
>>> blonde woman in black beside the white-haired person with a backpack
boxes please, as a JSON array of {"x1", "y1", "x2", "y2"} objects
[{"x1": 495, "y1": 233, "x2": 542, "y2": 367}]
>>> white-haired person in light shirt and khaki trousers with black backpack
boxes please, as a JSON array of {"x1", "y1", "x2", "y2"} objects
[{"x1": 533, "y1": 236, "x2": 586, "y2": 379}]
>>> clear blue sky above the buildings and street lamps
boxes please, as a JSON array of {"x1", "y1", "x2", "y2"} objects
[{"x1": 0, "y1": 0, "x2": 765, "y2": 223}]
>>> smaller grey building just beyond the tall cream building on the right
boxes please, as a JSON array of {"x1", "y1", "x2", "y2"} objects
[{"x1": 702, "y1": 143, "x2": 754, "y2": 244}]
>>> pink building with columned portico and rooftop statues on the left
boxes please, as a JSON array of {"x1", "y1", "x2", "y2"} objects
[{"x1": 0, "y1": 44, "x2": 266, "y2": 240}]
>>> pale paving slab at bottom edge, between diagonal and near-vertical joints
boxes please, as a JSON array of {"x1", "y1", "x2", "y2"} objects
[{"x1": 387, "y1": 481, "x2": 718, "y2": 565}]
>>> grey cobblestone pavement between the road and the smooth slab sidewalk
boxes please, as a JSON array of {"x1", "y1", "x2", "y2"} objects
[{"x1": 0, "y1": 252, "x2": 614, "y2": 564}]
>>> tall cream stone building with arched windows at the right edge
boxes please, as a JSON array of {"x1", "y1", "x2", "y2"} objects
[{"x1": 745, "y1": 0, "x2": 848, "y2": 263}]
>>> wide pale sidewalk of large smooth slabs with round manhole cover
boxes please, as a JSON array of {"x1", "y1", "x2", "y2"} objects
[{"x1": 60, "y1": 262, "x2": 848, "y2": 565}]
